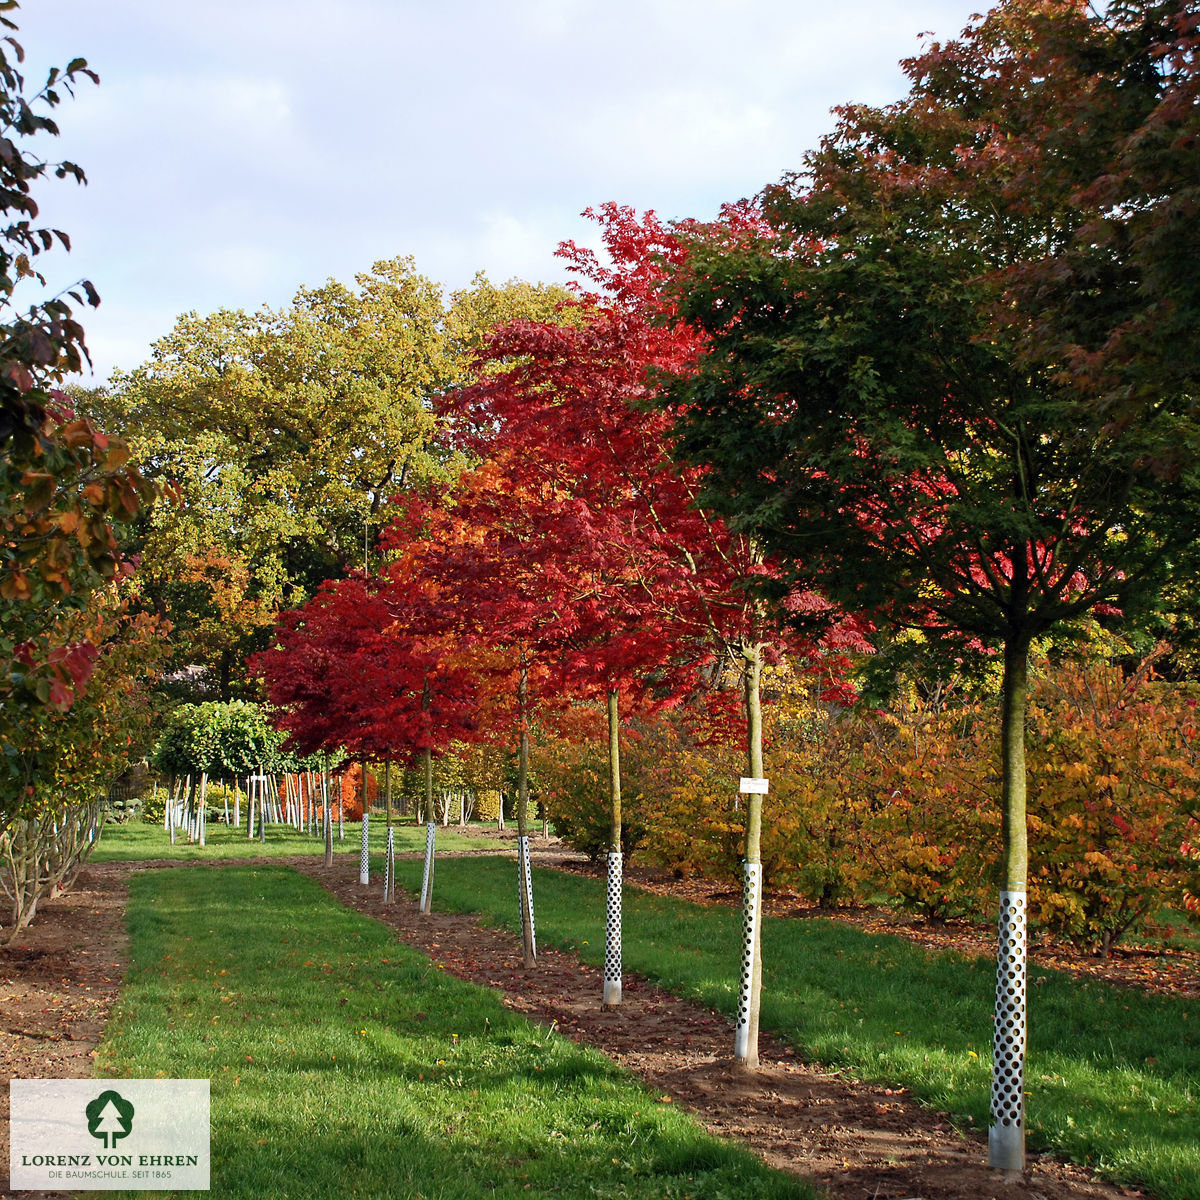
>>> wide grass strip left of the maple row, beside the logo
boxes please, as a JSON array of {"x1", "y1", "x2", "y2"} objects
[{"x1": 97, "y1": 865, "x2": 812, "y2": 1200}]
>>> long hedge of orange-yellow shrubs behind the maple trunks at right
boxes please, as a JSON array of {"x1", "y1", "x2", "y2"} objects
[{"x1": 544, "y1": 637, "x2": 1200, "y2": 955}]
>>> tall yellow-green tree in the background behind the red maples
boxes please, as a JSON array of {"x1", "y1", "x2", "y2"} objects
[{"x1": 87, "y1": 258, "x2": 565, "y2": 697}]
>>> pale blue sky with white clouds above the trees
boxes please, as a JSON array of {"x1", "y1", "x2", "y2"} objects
[{"x1": 16, "y1": 0, "x2": 979, "y2": 382}]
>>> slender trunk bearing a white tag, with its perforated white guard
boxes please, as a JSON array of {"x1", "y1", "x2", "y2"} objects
[{"x1": 733, "y1": 646, "x2": 766, "y2": 1070}]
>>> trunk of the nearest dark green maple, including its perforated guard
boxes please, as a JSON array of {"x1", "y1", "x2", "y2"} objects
[{"x1": 988, "y1": 637, "x2": 1030, "y2": 1171}]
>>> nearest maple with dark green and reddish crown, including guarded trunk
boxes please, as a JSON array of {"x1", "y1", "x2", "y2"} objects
[{"x1": 652, "y1": 0, "x2": 1200, "y2": 1170}]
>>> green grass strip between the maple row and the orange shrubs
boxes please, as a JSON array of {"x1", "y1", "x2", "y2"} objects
[{"x1": 386, "y1": 858, "x2": 1200, "y2": 1200}]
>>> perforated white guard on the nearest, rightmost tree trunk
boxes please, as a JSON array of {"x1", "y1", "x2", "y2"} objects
[{"x1": 988, "y1": 892, "x2": 1027, "y2": 1171}]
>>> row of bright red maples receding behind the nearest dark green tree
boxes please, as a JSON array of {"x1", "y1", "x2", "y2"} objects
[{"x1": 256, "y1": 206, "x2": 865, "y2": 1063}]
